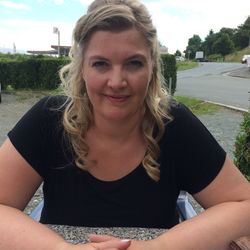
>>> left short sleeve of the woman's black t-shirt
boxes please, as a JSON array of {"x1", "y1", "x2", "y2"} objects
[{"x1": 8, "y1": 97, "x2": 66, "y2": 177}]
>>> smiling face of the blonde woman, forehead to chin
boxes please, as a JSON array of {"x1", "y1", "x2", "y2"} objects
[{"x1": 82, "y1": 28, "x2": 153, "y2": 121}]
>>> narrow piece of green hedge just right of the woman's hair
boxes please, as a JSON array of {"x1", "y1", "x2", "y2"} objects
[{"x1": 161, "y1": 54, "x2": 177, "y2": 95}]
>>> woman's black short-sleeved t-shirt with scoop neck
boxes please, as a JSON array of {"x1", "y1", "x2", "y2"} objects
[{"x1": 8, "y1": 96, "x2": 226, "y2": 228}]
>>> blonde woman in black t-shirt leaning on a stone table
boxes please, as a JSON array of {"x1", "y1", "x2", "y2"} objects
[{"x1": 0, "y1": 0, "x2": 250, "y2": 250}]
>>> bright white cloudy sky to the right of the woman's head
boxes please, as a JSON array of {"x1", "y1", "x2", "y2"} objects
[{"x1": 142, "y1": 0, "x2": 250, "y2": 53}]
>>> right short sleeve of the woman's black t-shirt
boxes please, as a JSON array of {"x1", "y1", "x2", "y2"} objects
[{"x1": 169, "y1": 103, "x2": 226, "y2": 194}]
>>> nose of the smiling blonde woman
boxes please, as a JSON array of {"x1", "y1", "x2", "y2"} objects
[{"x1": 108, "y1": 67, "x2": 127, "y2": 89}]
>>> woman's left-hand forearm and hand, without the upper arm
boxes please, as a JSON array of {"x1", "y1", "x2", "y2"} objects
[{"x1": 0, "y1": 205, "x2": 130, "y2": 250}]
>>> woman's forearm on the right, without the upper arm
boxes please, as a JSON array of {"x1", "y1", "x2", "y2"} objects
[{"x1": 151, "y1": 201, "x2": 250, "y2": 250}]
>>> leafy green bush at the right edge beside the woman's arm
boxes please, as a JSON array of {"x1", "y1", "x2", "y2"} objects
[{"x1": 234, "y1": 110, "x2": 250, "y2": 181}]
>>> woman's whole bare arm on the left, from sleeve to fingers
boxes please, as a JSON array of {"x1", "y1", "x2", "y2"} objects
[{"x1": 0, "y1": 139, "x2": 130, "y2": 250}]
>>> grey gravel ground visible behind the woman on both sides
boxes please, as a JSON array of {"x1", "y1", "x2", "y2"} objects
[{"x1": 0, "y1": 94, "x2": 243, "y2": 214}]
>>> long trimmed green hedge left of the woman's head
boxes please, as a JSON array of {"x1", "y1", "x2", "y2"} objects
[{"x1": 0, "y1": 57, "x2": 69, "y2": 89}]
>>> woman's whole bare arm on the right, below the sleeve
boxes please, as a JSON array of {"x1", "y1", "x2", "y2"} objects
[{"x1": 90, "y1": 158, "x2": 250, "y2": 250}]
